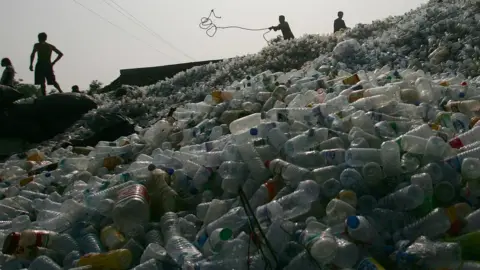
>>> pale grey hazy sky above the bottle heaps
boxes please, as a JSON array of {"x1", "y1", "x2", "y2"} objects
[{"x1": 0, "y1": 0, "x2": 427, "y2": 90}]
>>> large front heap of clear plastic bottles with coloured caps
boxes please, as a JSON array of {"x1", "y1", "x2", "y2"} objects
[{"x1": 0, "y1": 61, "x2": 480, "y2": 270}]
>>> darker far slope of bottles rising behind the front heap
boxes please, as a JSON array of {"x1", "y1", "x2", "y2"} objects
[{"x1": 35, "y1": 0, "x2": 480, "y2": 143}]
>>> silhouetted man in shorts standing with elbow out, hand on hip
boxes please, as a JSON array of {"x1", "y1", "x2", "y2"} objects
[{"x1": 30, "y1": 33, "x2": 63, "y2": 96}]
